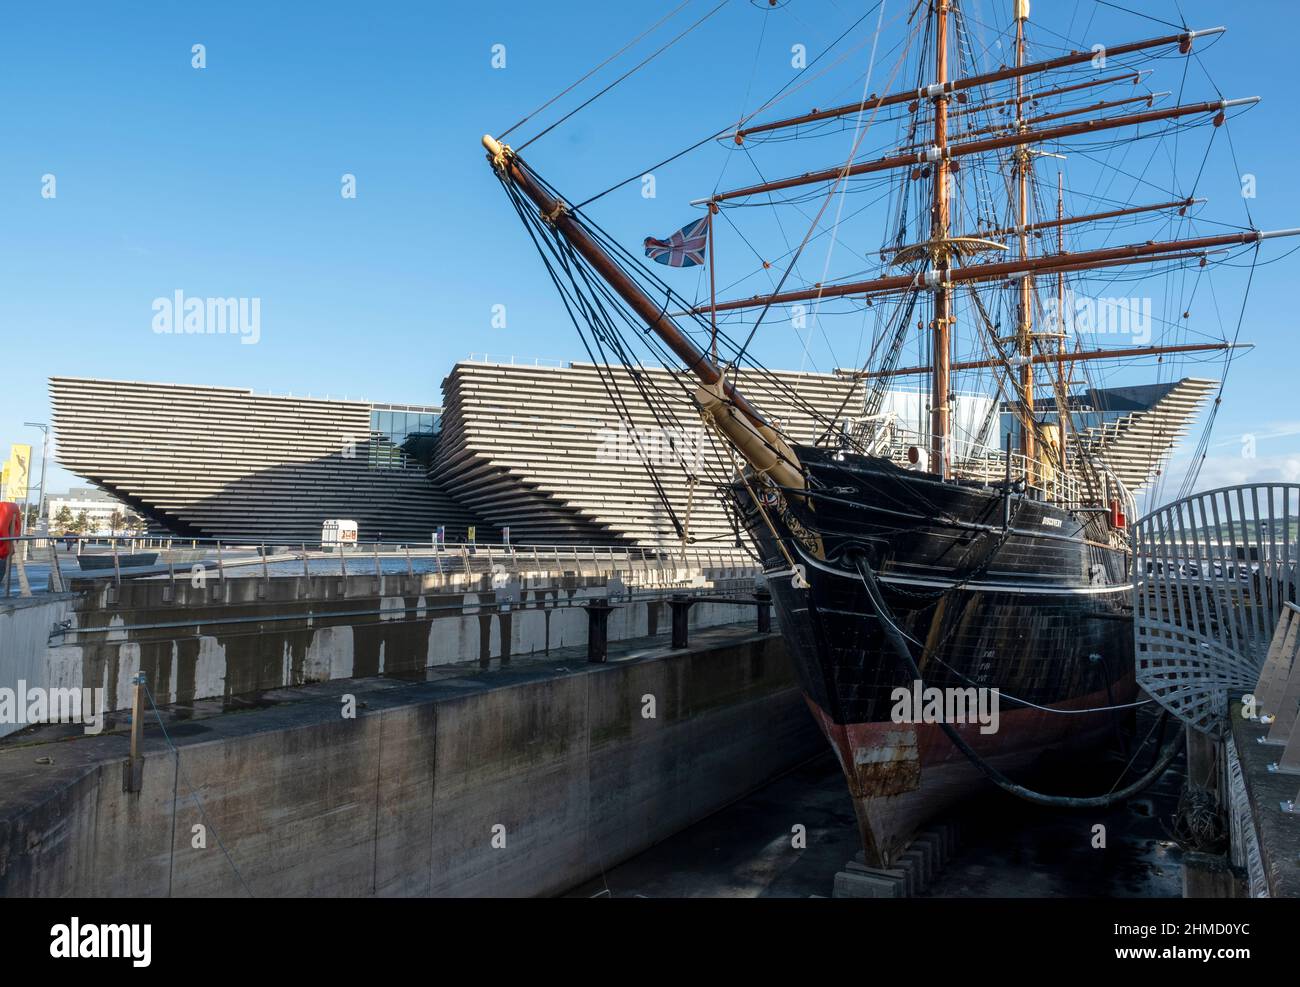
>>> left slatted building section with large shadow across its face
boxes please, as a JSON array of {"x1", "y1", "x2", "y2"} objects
[{"x1": 49, "y1": 377, "x2": 490, "y2": 544}]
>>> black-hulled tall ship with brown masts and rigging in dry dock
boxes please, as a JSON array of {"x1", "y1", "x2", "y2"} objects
[{"x1": 482, "y1": 0, "x2": 1297, "y2": 866}]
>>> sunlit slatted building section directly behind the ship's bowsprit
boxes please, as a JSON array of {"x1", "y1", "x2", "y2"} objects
[{"x1": 430, "y1": 363, "x2": 862, "y2": 547}]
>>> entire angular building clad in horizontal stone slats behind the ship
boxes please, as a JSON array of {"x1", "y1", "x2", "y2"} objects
[{"x1": 49, "y1": 360, "x2": 1212, "y2": 549}]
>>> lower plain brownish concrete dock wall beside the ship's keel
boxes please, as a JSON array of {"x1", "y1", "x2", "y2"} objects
[{"x1": 0, "y1": 629, "x2": 824, "y2": 896}]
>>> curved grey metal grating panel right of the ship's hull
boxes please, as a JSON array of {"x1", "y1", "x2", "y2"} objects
[{"x1": 1134, "y1": 484, "x2": 1300, "y2": 735}]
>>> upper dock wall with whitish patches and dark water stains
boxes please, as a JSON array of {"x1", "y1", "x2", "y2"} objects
[{"x1": 0, "y1": 571, "x2": 753, "y2": 736}]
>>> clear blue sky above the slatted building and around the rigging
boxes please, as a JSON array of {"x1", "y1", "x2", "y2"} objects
[{"x1": 0, "y1": 0, "x2": 1300, "y2": 501}]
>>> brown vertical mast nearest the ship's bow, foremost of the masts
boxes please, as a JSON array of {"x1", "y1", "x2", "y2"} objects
[{"x1": 930, "y1": 0, "x2": 954, "y2": 479}]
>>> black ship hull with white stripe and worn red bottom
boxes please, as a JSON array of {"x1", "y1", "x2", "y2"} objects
[{"x1": 738, "y1": 446, "x2": 1136, "y2": 866}]
